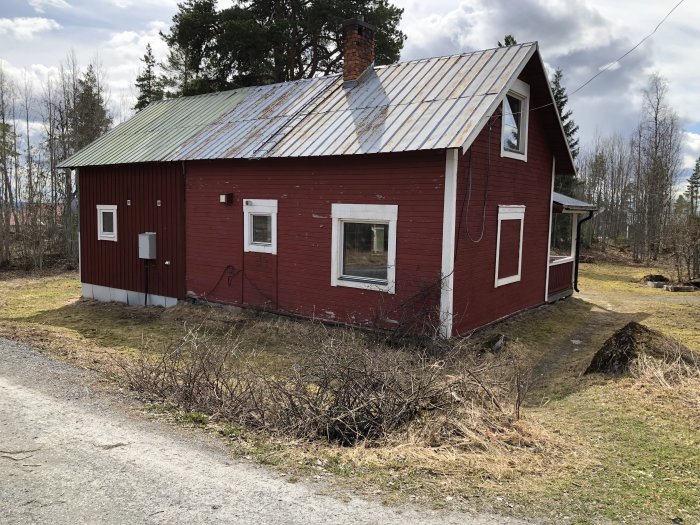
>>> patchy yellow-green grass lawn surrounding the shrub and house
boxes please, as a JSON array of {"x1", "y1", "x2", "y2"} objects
[{"x1": 0, "y1": 264, "x2": 700, "y2": 525}]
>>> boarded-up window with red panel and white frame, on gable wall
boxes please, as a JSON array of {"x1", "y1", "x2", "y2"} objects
[{"x1": 494, "y1": 205, "x2": 525, "y2": 288}]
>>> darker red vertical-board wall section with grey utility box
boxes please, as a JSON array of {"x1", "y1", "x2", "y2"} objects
[{"x1": 78, "y1": 163, "x2": 185, "y2": 298}]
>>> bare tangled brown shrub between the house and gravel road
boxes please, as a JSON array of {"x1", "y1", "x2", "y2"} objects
[{"x1": 121, "y1": 325, "x2": 536, "y2": 449}]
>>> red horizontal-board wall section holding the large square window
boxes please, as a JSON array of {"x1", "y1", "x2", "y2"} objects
[{"x1": 186, "y1": 151, "x2": 445, "y2": 326}]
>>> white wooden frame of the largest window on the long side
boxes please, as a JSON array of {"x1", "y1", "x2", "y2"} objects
[{"x1": 331, "y1": 204, "x2": 399, "y2": 294}]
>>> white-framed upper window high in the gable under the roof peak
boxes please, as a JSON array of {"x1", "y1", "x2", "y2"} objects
[{"x1": 501, "y1": 80, "x2": 530, "y2": 161}]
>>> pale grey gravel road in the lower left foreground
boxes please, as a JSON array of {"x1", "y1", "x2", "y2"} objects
[{"x1": 0, "y1": 339, "x2": 532, "y2": 525}]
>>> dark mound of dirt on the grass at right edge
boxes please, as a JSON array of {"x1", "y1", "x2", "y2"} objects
[{"x1": 584, "y1": 321, "x2": 700, "y2": 374}]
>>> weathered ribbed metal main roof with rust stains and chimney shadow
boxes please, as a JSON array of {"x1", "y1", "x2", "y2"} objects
[{"x1": 60, "y1": 43, "x2": 537, "y2": 167}]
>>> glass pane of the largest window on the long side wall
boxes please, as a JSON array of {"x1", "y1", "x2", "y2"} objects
[{"x1": 343, "y1": 222, "x2": 389, "y2": 281}]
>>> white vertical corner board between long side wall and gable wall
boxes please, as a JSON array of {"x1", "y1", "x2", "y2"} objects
[{"x1": 440, "y1": 149, "x2": 459, "y2": 338}]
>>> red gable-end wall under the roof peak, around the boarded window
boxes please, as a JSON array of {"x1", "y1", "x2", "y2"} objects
[{"x1": 453, "y1": 58, "x2": 555, "y2": 334}]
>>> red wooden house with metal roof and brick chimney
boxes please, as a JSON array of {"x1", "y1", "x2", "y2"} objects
[{"x1": 62, "y1": 19, "x2": 592, "y2": 336}]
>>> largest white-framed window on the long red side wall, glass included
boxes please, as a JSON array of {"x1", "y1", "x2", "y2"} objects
[{"x1": 331, "y1": 204, "x2": 398, "y2": 293}]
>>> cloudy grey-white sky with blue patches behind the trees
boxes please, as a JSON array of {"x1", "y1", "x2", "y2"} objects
[{"x1": 0, "y1": 0, "x2": 700, "y2": 176}]
